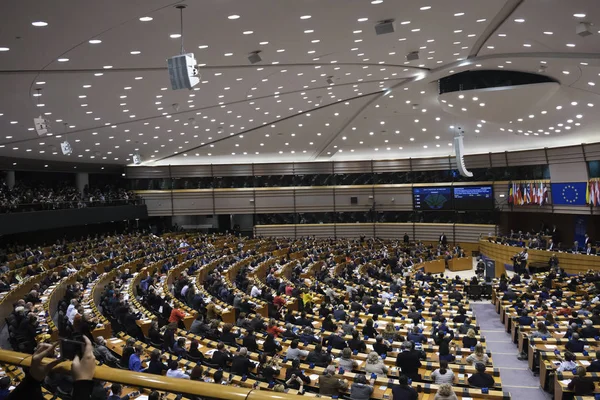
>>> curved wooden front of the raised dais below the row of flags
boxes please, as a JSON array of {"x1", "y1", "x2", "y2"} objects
[{"x1": 479, "y1": 238, "x2": 600, "y2": 274}]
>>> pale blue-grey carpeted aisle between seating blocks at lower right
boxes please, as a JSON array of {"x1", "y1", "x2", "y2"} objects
[{"x1": 471, "y1": 302, "x2": 551, "y2": 400}]
